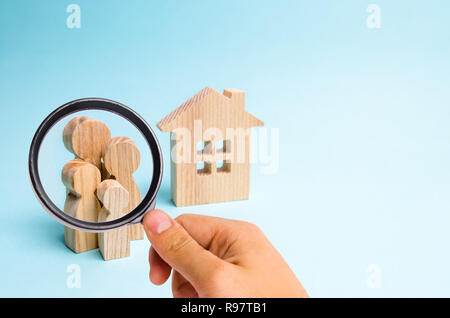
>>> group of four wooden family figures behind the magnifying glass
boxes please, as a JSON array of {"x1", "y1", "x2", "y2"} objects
[{"x1": 62, "y1": 116, "x2": 144, "y2": 260}]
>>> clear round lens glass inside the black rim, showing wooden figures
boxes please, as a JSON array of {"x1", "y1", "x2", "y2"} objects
[{"x1": 39, "y1": 111, "x2": 152, "y2": 223}]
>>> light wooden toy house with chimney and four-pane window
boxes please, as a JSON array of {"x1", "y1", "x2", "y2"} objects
[{"x1": 157, "y1": 87, "x2": 264, "y2": 206}]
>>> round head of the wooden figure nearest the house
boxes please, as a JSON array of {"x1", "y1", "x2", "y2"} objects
[{"x1": 103, "y1": 137, "x2": 141, "y2": 176}]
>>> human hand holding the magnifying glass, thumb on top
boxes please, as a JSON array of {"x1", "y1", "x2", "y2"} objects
[{"x1": 142, "y1": 210, "x2": 308, "y2": 298}]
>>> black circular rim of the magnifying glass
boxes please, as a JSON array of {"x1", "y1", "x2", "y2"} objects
[{"x1": 28, "y1": 98, "x2": 163, "y2": 233}]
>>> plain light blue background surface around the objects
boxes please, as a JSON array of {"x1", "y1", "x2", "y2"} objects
[{"x1": 0, "y1": 0, "x2": 450, "y2": 297}]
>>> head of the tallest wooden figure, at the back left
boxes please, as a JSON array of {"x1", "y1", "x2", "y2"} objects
[{"x1": 63, "y1": 116, "x2": 111, "y2": 171}]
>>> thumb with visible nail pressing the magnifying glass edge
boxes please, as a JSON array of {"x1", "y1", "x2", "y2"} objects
[{"x1": 142, "y1": 210, "x2": 222, "y2": 287}]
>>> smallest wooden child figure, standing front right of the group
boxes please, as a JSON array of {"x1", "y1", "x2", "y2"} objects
[{"x1": 97, "y1": 180, "x2": 130, "y2": 261}]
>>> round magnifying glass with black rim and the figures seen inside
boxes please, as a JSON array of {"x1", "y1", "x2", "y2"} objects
[{"x1": 29, "y1": 99, "x2": 162, "y2": 239}]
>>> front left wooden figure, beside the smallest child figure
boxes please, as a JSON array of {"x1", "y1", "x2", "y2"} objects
[{"x1": 62, "y1": 159, "x2": 101, "y2": 253}]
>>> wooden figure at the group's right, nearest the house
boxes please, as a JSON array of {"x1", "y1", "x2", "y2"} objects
[{"x1": 103, "y1": 137, "x2": 144, "y2": 240}]
